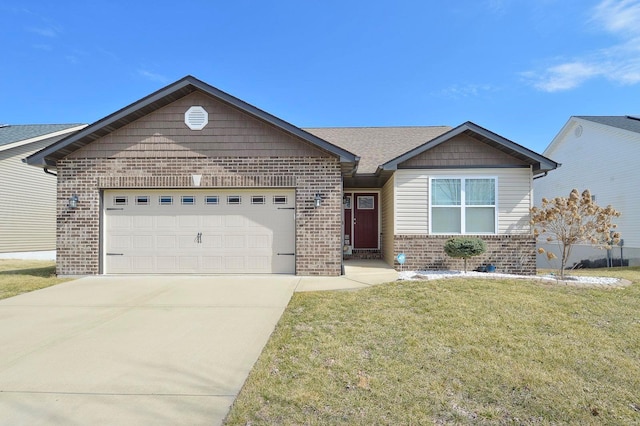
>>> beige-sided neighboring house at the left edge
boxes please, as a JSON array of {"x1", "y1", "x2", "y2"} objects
[{"x1": 0, "y1": 124, "x2": 84, "y2": 258}]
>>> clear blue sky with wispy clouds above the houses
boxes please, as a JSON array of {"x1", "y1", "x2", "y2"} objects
[{"x1": 0, "y1": 0, "x2": 640, "y2": 152}]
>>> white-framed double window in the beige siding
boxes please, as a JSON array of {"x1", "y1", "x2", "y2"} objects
[{"x1": 430, "y1": 178, "x2": 497, "y2": 234}]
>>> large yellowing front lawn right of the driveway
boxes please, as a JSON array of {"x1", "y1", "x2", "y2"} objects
[{"x1": 226, "y1": 268, "x2": 640, "y2": 425}]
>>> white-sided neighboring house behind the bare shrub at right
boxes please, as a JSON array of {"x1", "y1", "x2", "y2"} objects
[{"x1": 535, "y1": 116, "x2": 640, "y2": 268}]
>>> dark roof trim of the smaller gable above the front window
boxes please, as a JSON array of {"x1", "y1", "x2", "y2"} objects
[{"x1": 378, "y1": 121, "x2": 558, "y2": 175}]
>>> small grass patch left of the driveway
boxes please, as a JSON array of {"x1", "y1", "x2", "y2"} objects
[{"x1": 0, "y1": 259, "x2": 69, "y2": 299}]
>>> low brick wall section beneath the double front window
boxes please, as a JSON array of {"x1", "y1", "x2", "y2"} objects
[{"x1": 394, "y1": 235, "x2": 536, "y2": 275}]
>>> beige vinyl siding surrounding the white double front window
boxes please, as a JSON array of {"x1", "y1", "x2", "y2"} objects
[{"x1": 395, "y1": 167, "x2": 532, "y2": 235}]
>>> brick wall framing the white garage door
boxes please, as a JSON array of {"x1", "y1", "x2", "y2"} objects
[{"x1": 57, "y1": 157, "x2": 342, "y2": 276}]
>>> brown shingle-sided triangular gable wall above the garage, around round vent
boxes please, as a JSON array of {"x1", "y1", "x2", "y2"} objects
[{"x1": 66, "y1": 91, "x2": 331, "y2": 158}]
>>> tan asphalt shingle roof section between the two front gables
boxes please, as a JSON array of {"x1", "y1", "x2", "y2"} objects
[{"x1": 303, "y1": 126, "x2": 451, "y2": 174}]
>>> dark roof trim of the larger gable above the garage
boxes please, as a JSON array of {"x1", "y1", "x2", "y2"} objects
[{"x1": 27, "y1": 76, "x2": 359, "y2": 170}]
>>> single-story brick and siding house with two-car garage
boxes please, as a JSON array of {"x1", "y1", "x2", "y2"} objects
[{"x1": 27, "y1": 76, "x2": 557, "y2": 276}]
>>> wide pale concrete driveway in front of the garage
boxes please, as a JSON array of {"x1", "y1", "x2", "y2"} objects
[{"x1": 0, "y1": 276, "x2": 300, "y2": 425}]
